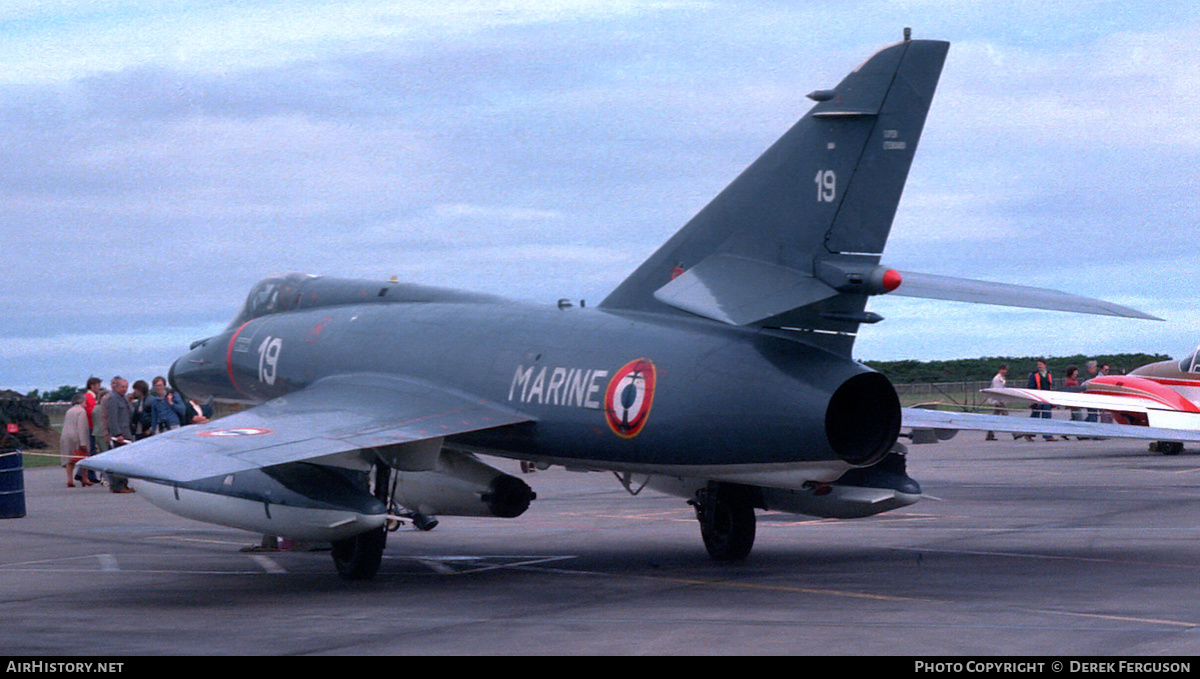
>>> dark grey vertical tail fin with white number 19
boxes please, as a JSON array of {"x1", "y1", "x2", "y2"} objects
[{"x1": 600, "y1": 40, "x2": 949, "y2": 350}]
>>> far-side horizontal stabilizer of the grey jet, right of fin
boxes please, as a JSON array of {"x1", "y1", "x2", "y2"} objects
[{"x1": 892, "y1": 271, "x2": 1163, "y2": 320}]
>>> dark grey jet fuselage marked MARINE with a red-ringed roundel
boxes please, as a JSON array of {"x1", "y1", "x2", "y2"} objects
[{"x1": 170, "y1": 281, "x2": 899, "y2": 485}]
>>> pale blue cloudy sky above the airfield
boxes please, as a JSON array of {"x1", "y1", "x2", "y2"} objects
[{"x1": 0, "y1": 0, "x2": 1200, "y2": 391}]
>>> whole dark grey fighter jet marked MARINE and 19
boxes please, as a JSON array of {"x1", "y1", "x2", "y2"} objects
[{"x1": 84, "y1": 34, "x2": 1145, "y2": 578}]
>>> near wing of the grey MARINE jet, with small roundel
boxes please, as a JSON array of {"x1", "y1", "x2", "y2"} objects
[{"x1": 82, "y1": 374, "x2": 533, "y2": 482}]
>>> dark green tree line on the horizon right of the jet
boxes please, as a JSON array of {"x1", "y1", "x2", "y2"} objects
[{"x1": 863, "y1": 354, "x2": 1171, "y2": 385}]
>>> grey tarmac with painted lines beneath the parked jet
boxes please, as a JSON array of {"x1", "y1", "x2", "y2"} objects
[{"x1": 0, "y1": 432, "x2": 1200, "y2": 657}]
